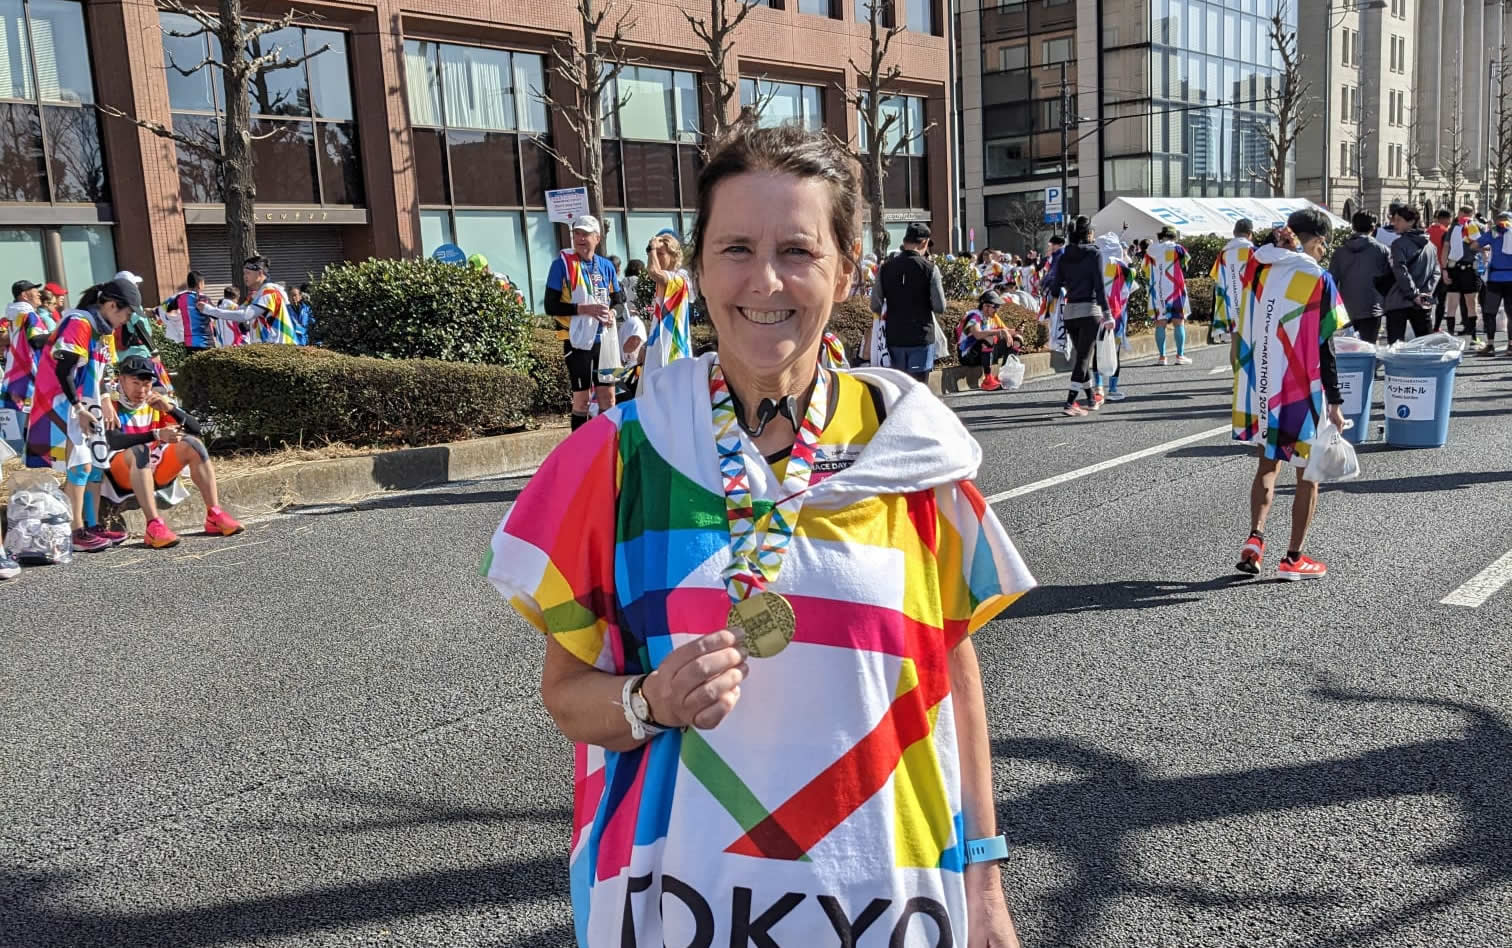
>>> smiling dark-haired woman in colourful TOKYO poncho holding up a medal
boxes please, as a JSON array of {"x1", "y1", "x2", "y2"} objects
[{"x1": 485, "y1": 125, "x2": 1033, "y2": 948}]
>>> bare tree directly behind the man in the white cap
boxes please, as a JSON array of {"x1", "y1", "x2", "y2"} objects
[{"x1": 531, "y1": 0, "x2": 635, "y2": 218}]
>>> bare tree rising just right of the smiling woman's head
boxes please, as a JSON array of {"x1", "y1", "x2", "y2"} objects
[{"x1": 835, "y1": 0, "x2": 934, "y2": 260}]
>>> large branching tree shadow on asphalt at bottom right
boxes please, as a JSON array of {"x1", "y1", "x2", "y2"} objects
[{"x1": 993, "y1": 679, "x2": 1512, "y2": 948}]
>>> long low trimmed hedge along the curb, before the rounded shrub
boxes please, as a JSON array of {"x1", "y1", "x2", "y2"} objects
[{"x1": 177, "y1": 345, "x2": 535, "y2": 449}]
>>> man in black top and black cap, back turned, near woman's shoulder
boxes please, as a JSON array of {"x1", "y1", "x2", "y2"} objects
[{"x1": 871, "y1": 224, "x2": 945, "y2": 384}]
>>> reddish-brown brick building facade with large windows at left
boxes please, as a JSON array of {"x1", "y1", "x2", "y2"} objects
[{"x1": 0, "y1": 0, "x2": 956, "y2": 304}]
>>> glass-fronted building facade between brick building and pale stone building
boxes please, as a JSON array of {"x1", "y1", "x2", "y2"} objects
[{"x1": 959, "y1": 0, "x2": 1296, "y2": 249}]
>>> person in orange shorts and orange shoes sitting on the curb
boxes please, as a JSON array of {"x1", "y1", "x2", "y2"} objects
[{"x1": 106, "y1": 355, "x2": 243, "y2": 549}]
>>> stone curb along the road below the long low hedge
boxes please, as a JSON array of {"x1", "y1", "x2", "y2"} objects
[{"x1": 116, "y1": 428, "x2": 569, "y2": 537}]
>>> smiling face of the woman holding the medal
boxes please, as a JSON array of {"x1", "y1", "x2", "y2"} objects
[{"x1": 699, "y1": 171, "x2": 851, "y2": 373}]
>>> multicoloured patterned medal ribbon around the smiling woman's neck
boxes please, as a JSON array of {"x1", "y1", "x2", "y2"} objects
[{"x1": 709, "y1": 361, "x2": 830, "y2": 602}]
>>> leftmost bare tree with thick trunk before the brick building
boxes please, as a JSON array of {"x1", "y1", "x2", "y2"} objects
[{"x1": 95, "y1": 0, "x2": 331, "y2": 287}]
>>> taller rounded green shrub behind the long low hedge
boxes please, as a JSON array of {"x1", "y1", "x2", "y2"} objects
[{"x1": 310, "y1": 259, "x2": 532, "y2": 369}]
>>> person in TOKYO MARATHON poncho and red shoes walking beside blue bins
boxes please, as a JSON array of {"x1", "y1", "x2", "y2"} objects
[{"x1": 1232, "y1": 207, "x2": 1349, "y2": 579}]
